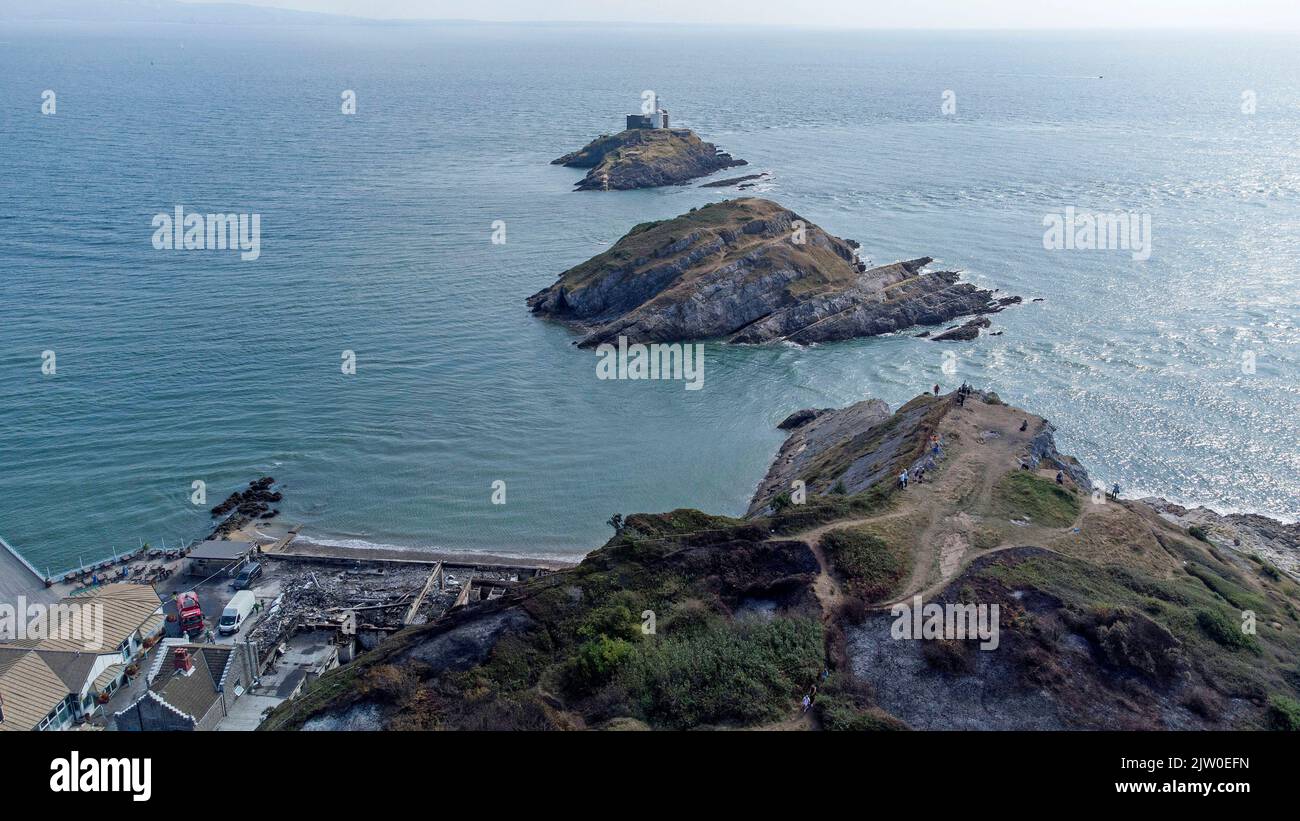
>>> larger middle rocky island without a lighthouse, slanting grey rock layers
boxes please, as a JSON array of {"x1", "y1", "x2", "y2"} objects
[{"x1": 528, "y1": 197, "x2": 1021, "y2": 347}]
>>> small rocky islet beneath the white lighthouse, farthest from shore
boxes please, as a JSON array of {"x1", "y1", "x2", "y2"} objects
[{"x1": 551, "y1": 129, "x2": 746, "y2": 191}]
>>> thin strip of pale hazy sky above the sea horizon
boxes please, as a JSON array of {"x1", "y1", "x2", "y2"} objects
[{"x1": 195, "y1": 0, "x2": 1300, "y2": 30}]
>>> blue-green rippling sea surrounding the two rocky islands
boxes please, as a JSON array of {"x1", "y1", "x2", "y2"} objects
[{"x1": 0, "y1": 23, "x2": 1300, "y2": 570}]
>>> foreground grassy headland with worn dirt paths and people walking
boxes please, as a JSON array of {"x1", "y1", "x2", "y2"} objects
[{"x1": 267, "y1": 391, "x2": 1300, "y2": 730}]
